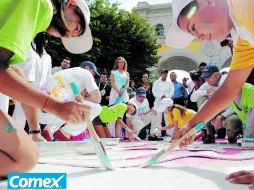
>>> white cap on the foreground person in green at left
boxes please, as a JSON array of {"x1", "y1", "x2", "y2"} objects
[{"x1": 61, "y1": 0, "x2": 93, "y2": 54}]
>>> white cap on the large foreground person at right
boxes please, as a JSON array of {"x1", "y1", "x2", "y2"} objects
[{"x1": 166, "y1": 0, "x2": 194, "y2": 48}]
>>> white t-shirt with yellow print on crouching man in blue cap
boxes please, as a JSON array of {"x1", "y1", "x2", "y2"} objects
[{"x1": 46, "y1": 67, "x2": 98, "y2": 101}]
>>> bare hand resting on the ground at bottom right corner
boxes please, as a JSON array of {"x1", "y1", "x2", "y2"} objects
[{"x1": 225, "y1": 170, "x2": 254, "y2": 189}]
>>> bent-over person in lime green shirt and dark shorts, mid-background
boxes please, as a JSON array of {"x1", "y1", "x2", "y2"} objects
[{"x1": 93, "y1": 103, "x2": 137, "y2": 138}]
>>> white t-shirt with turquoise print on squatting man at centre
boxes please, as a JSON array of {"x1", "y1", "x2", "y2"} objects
[{"x1": 127, "y1": 97, "x2": 150, "y2": 119}]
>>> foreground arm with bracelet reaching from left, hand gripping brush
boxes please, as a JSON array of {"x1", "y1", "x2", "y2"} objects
[{"x1": 0, "y1": 47, "x2": 90, "y2": 123}]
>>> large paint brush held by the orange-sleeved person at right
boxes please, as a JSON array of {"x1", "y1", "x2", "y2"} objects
[{"x1": 141, "y1": 122, "x2": 205, "y2": 168}]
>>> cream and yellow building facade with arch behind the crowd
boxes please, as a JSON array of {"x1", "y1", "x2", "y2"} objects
[{"x1": 132, "y1": 1, "x2": 231, "y2": 72}]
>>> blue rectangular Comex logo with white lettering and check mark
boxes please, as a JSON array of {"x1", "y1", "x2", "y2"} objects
[{"x1": 8, "y1": 173, "x2": 67, "y2": 189}]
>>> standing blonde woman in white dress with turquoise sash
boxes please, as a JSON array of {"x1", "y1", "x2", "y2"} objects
[{"x1": 109, "y1": 57, "x2": 129, "y2": 105}]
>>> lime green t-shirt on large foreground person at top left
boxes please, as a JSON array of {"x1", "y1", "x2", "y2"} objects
[{"x1": 0, "y1": 0, "x2": 53, "y2": 64}]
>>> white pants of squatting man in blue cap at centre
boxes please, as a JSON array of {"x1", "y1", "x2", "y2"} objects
[{"x1": 129, "y1": 112, "x2": 161, "y2": 135}]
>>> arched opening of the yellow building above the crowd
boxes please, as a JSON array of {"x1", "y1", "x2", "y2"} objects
[{"x1": 160, "y1": 56, "x2": 198, "y2": 72}]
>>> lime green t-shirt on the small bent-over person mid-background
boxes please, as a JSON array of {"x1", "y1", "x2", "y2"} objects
[{"x1": 99, "y1": 103, "x2": 127, "y2": 123}]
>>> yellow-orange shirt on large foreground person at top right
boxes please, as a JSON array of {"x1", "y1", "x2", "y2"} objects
[{"x1": 228, "y1": 0, "x2": 254, "y2": 70}]
